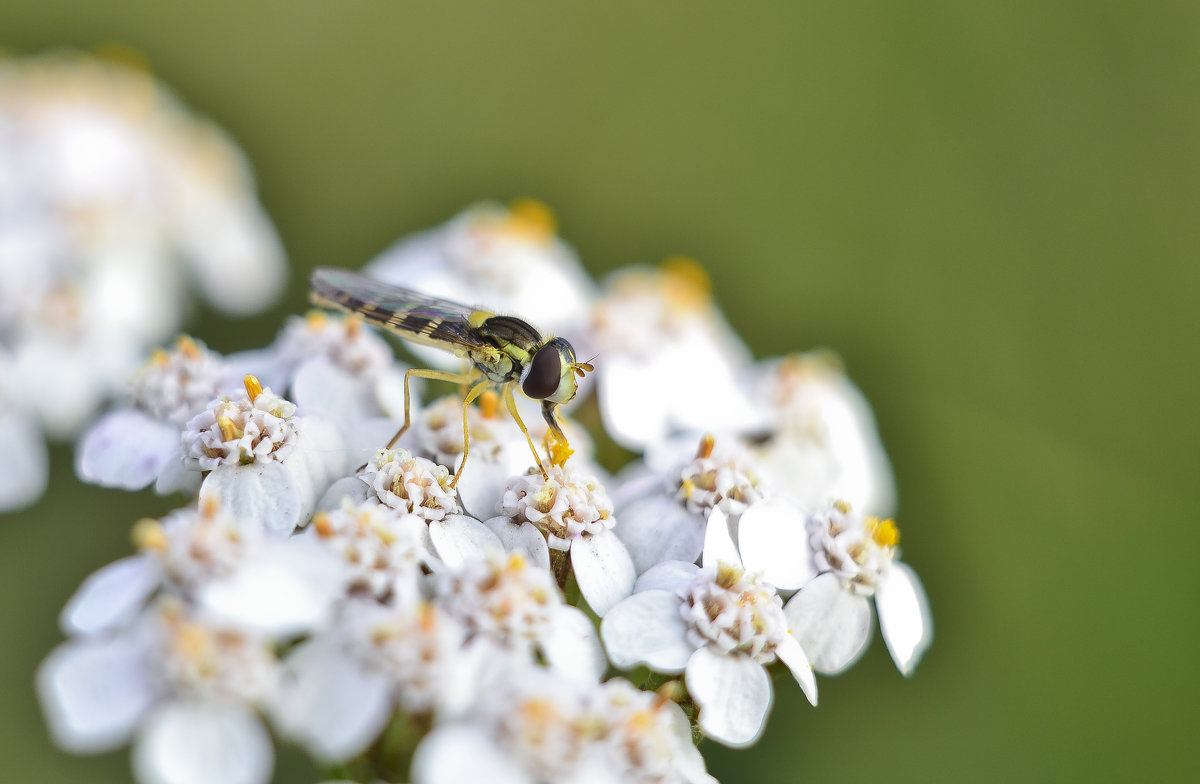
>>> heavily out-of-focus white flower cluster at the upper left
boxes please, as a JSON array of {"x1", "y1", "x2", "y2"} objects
[{"x1": 0, "y1": 54, "x2": 287, "y2": 511}]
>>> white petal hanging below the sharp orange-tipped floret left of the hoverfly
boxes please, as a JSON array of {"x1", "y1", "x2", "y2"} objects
[{"x1": 200, "y1": 462, "x2": 305, "y2": 534}]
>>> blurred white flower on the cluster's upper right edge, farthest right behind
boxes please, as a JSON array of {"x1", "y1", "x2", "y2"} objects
[{"x1": 755, "y1": 352, "x2": 895, "y2": 515}]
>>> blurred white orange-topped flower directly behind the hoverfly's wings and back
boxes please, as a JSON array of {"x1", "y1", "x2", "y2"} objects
[{"x1": 364, "y1": 199, "x2": 595, "y2": 370}]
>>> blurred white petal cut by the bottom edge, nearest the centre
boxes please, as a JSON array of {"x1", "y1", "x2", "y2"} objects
[{"x1": 410, "y1": 724, "x2": 534, "y2": 784}]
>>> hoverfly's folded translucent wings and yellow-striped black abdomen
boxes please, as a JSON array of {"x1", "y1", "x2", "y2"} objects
[{"x1": 310, "y1": 267, "x2": 494, "y2": 353}]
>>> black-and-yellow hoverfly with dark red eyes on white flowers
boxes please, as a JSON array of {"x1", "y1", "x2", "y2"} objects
[{"x1": 311, "y1": 268, "x2": 594, "y2": 486}]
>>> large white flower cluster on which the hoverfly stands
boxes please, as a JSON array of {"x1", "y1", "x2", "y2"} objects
[{"x1": 38, "y1": 202, "x2": 932, "y2": 784}]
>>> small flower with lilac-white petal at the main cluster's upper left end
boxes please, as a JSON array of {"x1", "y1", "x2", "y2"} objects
[{"x1": 76, "y1": 336, "x2": 239, "y2": 492}]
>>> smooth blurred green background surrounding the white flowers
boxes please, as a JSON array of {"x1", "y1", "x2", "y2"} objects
[{"x1": 0, "y1": 0, "x2": 1200, "y2": 783}]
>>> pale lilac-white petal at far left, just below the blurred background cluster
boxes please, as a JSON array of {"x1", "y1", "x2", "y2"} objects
[{"x1": 76, "y1": 408, "x2": 180, "y2": 490}]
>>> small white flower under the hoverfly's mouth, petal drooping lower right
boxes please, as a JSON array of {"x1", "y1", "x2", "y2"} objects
[{"x1": 486, "y1": 462, "x2": 637, "y2": 616}]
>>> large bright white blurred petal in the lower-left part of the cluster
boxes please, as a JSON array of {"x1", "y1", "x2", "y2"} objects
[{"x1": 197, "y1": 537, "x2": 343, "y2": 635}]
